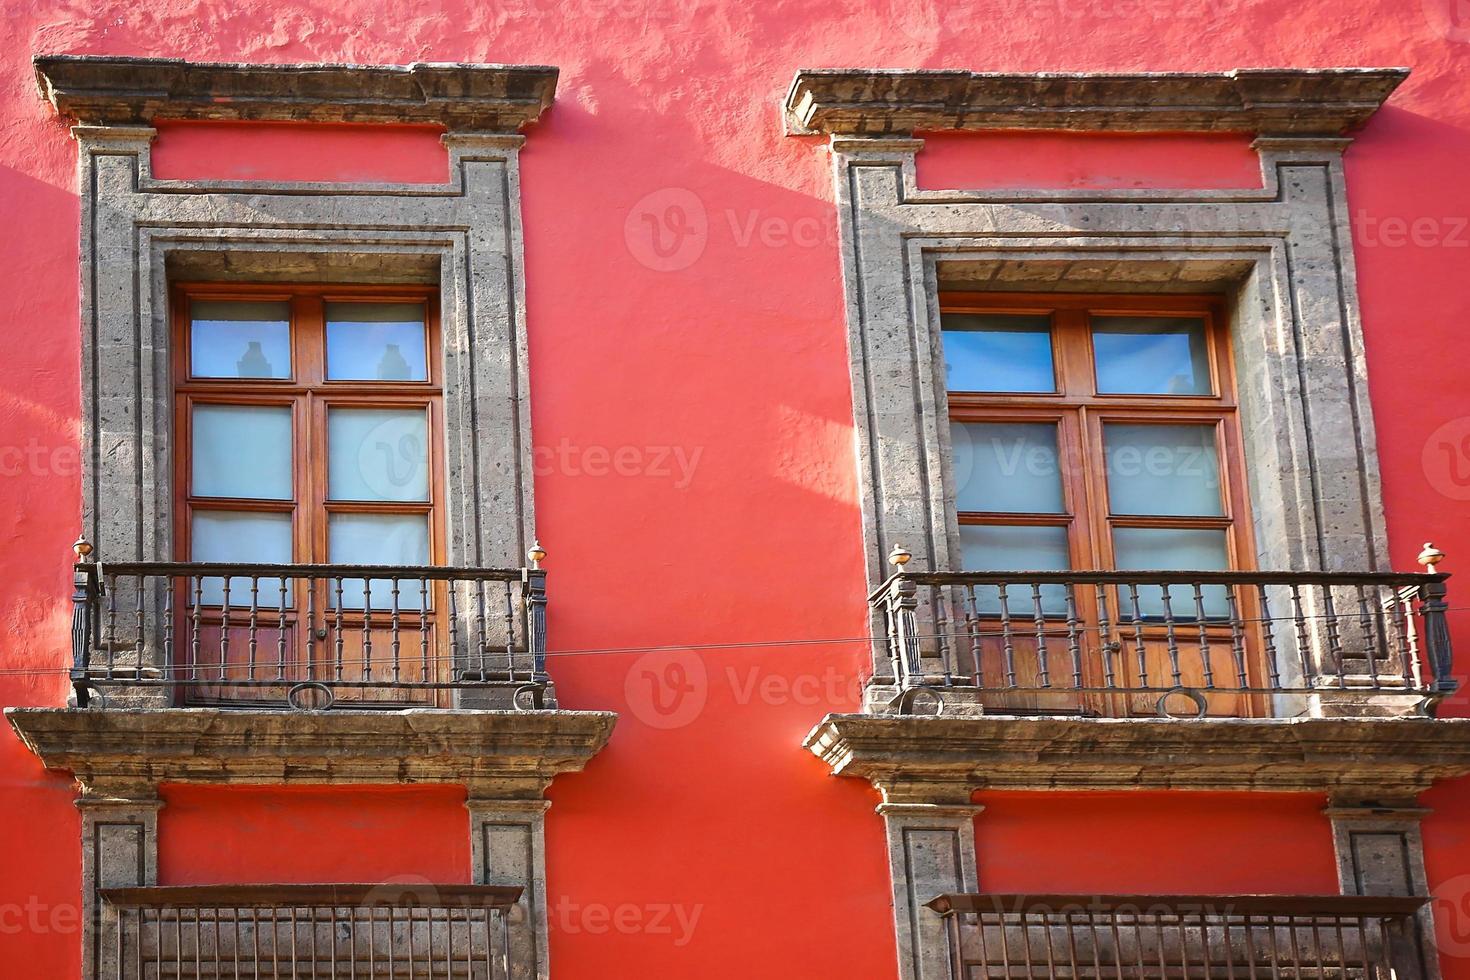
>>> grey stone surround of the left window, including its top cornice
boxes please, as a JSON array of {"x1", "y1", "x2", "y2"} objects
[{"x1": 35, "y1": 56, "x2": 557, "y2": 590}]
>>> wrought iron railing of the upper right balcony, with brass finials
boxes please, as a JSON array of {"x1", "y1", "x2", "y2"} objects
[{"x1": 869, "y1": 545, "x2": 1455, "y2": 716}]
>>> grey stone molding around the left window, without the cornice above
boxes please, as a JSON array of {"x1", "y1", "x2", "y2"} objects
[{"x1": 61, "y1": 110, "x2": 554, "y2": 693}]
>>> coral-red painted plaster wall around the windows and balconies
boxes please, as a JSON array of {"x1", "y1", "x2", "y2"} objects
[{"x1": 0, "y1": 0, "x2": 1470, "y2": 980}]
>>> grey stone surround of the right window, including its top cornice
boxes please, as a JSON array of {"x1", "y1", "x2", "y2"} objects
[{"x1": 785, "y1": 69, "x2": 1407, "y2": 696}]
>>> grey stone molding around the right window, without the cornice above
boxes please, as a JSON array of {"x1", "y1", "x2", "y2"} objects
[{"x1": 832, "y1": 137, "x2": 1388, "y2": 711}]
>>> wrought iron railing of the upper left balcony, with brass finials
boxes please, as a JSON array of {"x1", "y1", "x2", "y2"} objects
[{"x1": 72, "y1": 542, "x2": 550, "y2": 708}]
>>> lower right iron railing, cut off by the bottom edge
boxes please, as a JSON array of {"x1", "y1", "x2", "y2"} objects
[{"x1": 929, "y1": 895, "x2": 1427, "y2": 980}]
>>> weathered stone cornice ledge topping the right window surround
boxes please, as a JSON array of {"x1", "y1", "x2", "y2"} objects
[{"x1": 785, "y1": 68, "x2": 1408, "y2": 137}]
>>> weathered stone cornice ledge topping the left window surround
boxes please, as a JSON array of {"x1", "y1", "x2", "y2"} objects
[{"x1": 34, "y1": 54, "x2": 557, "y2": 132}]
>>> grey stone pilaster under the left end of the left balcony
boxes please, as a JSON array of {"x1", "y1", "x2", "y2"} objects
[{"x1": 76, "y1": 782, "x2": 163, "y2": 977}]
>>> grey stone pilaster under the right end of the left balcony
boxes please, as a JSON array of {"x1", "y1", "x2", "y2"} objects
[{"x1": 465, "y1": 780, "x2": 551, "y2": 980}]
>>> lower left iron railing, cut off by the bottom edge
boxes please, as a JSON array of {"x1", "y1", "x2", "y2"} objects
[{"x1": 98, "y1": 884, "x2": 520, "y2": 980}]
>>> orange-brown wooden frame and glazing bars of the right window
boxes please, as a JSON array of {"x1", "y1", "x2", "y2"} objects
[{"x1": 939, "y1": 292, "x2": 1263, "y2": 714}]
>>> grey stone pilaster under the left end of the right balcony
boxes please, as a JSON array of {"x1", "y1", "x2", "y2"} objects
[{"x1": 878, "y1": 782, "x2": 980, "y2": 980}]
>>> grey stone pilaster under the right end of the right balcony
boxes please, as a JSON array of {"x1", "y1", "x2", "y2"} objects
[{"x1": 1324, "y1": 796, "x2": 1439, "y2": 980}]
